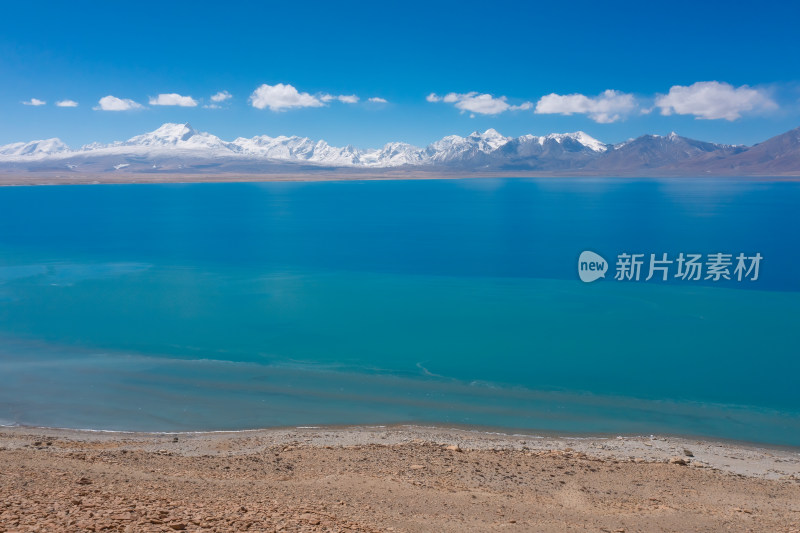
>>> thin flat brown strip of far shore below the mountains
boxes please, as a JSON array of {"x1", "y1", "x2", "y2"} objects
[{"x1": 0, "y1": 168, "x2": 800, "y2": 187}]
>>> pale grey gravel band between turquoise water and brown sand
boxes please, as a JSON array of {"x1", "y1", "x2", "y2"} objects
[{"x1": 0, "y1": 424, "x2": 800, "y2": 483}]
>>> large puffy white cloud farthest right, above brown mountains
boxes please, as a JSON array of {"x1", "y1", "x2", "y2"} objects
[{"x1": 656, "y1": 81, "x2": 778, "y2": 120}]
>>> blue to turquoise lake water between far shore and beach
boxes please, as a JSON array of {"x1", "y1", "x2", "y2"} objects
[{"x1": 0, "y1": 178, "x2": 800, "y2": 446}]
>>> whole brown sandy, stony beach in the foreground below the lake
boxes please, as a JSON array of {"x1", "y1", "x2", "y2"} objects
[{"x1": 0, "y1": 426, "x2": 800, "y2": 533}]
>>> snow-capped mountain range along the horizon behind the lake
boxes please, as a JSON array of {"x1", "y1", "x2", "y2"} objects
[{"x1": 0, "y1": 124, "x2": 800, "y2": 176}]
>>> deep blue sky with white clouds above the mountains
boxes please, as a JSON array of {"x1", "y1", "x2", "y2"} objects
[{"x1": 0, "y1": 0, "x2": 800, "y2": 148}]
